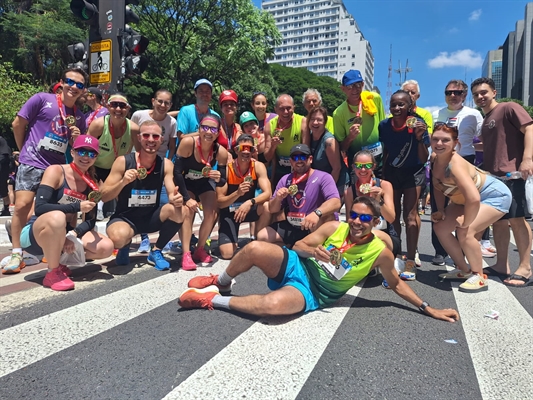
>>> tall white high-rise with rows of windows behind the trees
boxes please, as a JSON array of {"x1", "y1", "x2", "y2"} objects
[{"x1": 262, "y1": 0, "x2": 374, "y2": 90}]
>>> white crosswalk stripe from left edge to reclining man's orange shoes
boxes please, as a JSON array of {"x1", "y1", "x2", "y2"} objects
[{"x1": 0, "y1": 260, "x2": 229, "y2": 377}]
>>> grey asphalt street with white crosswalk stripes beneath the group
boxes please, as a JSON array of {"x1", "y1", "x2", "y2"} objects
[{"x1": 0, "y1": 211, "x2": 533, "y2": 400}]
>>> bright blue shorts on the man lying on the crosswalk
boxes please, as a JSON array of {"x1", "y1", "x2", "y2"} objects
[{"x1": 268, "y1": 247, "x2": 319, "y2": 312}]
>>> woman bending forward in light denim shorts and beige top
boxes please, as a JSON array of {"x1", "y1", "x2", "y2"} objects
[{"x1": 431, "y1": 123, "x2": 511, "y2": 292}]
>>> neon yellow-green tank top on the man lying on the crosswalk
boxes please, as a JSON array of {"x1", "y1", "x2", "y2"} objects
[{"x1": 300, "y1": 222, "x2": 385, "y2": 308}]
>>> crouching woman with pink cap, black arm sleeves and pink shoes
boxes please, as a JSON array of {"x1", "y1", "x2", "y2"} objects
[{"x1": 20, "y1": 135, "x2": 113, "y2": 291}]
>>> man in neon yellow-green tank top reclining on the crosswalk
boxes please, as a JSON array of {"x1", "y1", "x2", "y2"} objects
[{"x1": 178, "y1": 197, "x2": 459, "y2": 322}]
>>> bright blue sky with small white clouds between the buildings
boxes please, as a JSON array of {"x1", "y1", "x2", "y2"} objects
[{"x1": 253, "y1": 0, "x2": 528, "y2": 110}]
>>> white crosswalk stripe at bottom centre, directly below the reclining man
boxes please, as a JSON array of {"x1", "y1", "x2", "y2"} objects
[{"x1": 164, "y1": 280, "x2": 365, "y2": 400}]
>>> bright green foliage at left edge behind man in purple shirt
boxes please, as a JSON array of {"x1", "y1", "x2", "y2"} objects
[{"x1": 0, "y1": 58, "x2": 44, "y2": 148}]
